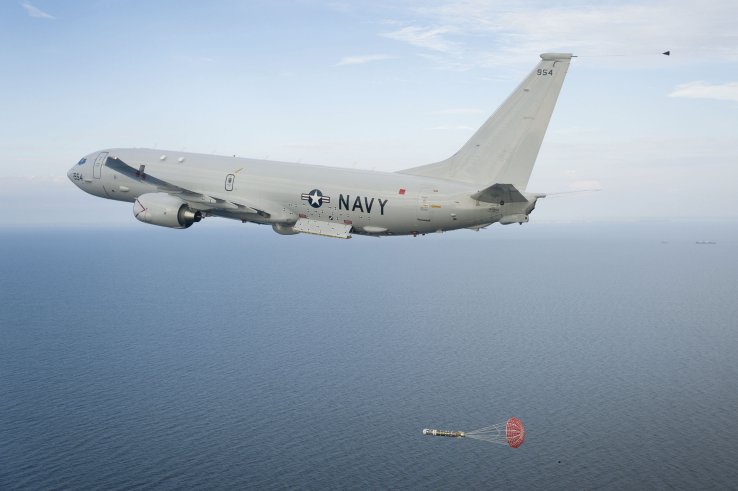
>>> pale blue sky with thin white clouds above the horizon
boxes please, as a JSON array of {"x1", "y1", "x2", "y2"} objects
[{"x1": 0, "y1": 0, "x2": 738, "y2": 226}]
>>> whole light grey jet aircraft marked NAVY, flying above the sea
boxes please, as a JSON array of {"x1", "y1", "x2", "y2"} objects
[{"x1": 67, "y1": 53, "x2": 572, "y2": 239}]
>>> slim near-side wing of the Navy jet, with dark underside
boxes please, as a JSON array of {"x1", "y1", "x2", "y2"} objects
[{"x1": 105, "y1": 157, "x2": 270, "y2": 218}]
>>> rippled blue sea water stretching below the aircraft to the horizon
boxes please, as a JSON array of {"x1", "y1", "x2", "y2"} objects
[{"x1": 0, "y1": 223, "x2": 738, "y2": 489}]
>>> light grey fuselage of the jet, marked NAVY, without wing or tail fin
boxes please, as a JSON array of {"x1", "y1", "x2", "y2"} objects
[{"x1": 68, "y1": 149, "x2": 529, "y2": 235}]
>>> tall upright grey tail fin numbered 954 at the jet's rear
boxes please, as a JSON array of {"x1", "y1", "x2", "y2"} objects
[{"x1": 400, "y1": 53, "x2": 572, "y2": 190}]
